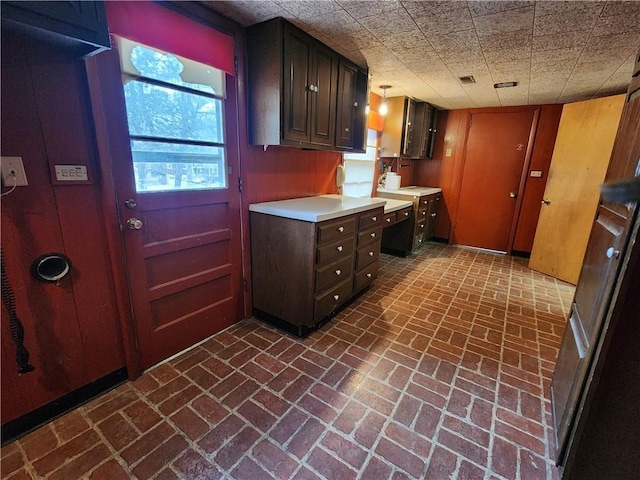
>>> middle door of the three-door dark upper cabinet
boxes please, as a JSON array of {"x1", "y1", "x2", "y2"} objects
[{"x1": 309, "y1": 44, "x2": 338, "y2": 147}]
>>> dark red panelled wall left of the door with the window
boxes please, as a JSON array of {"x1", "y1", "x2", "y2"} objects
[{"x1": 1, "y1": 29, "x2": 124, "y2": 423}]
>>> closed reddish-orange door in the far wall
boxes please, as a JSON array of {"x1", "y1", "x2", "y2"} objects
[{"x1": 454, "y1": 110, "x2": 535, "y2": 251}]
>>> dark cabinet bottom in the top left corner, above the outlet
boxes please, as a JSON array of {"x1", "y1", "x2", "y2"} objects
[{"x1": 2, "y1": 1, "x2": 111, "y2": 57}]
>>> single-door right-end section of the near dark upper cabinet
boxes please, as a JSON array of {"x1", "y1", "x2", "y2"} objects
[{"x1": 336, "y1": 58, "x2": 369, "y2": 151}]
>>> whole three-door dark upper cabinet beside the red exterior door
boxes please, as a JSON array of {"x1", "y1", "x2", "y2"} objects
[{"x1": 247, "y1": 18, "x2": 368, "y2": 151}]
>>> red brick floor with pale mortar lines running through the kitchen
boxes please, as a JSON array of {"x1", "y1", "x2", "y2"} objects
[{"x1": 2, "y1": 244, "x2": 573, "y2": 480}]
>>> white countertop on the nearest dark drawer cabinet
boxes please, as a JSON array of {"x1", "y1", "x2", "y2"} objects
[{"x1": 249, "y1": 195, "x2": 386, "y2": 222}]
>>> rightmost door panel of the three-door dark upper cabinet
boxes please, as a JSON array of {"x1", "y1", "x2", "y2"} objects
[{"x1": 336, "y1": 58, "x2": 358, "y2": 148}]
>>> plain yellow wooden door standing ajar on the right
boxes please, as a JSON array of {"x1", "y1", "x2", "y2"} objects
[{"x1": 529, "y1": 95, "x2": 625, "y2": 284}]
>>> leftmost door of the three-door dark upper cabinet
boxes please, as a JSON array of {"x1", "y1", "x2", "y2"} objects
[{"x1": 282, "y1": 28, "x2": 312, "y2": 142}]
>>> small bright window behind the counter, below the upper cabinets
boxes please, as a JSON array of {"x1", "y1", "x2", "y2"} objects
[{"x1": 342, "y1": 129, "x2": 378, "y2": 197}]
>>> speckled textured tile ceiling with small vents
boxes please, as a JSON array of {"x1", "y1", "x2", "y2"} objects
[{"x1": 202, "y1": 0, "x2": 640, "y2": 109}]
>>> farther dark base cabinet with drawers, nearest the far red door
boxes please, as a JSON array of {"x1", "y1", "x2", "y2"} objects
[{"x1": 378, "y1": 191, "x2": 442, "y2": 257}]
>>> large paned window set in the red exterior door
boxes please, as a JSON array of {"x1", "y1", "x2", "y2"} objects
[{"x1": 119, "y1": 39, "x2": 227, "y2": 193}]
